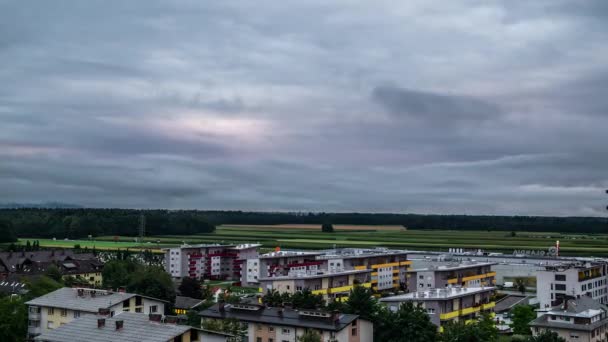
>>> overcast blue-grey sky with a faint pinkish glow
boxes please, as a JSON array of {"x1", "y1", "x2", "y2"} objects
[{"x1": 0, "y1": 0, "x2": 608, "y2": 216}]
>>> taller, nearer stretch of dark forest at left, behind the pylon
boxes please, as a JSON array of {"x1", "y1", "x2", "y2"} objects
[{"x1": 0, "y1": 208, "x2": 215, "y2": 242}]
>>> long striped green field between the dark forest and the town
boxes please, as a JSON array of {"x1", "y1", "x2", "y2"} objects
[{"x1": 22, "y1": 225, "x2": 608, "y2": 256}]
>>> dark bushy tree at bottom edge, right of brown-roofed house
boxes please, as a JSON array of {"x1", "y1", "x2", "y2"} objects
[{"x1": 374, "y1": 302, "x2": 437, "y2": 342}]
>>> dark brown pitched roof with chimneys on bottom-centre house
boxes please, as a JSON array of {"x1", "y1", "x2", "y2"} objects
[{"x1": 199, "y1": 304, "x2": 359, "y2": 331}]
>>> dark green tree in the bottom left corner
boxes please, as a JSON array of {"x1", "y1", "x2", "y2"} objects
[{"x1": 0, "y1": 297, "x2": 27, "y2": 342}]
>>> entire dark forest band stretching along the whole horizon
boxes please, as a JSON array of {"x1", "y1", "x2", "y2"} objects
[{"x1": 0, "y1": 208, "x2": 608, "y2": 243}]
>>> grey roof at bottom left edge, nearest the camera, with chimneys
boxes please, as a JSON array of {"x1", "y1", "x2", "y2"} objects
[{"x1": 34, "y1": 312, "x2": 191, "y2": 342}]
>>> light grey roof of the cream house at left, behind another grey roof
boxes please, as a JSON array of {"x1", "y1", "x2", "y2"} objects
[{"x1": 25, "y1": 287, "x2": 136, "y2": 312}]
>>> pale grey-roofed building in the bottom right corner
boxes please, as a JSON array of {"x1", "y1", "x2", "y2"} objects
[{"x1": 530, "y1": 297, "x2": 608, "y2": 342}]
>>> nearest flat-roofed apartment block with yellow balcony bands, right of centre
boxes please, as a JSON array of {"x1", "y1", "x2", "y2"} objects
[{"x1": 380, "y1": 287, "x2": 496, "y2": 331}]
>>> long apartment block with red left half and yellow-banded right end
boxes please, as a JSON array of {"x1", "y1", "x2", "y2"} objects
[{"x1": 246, "y1": 248, "x2": 411, "y2": 292}]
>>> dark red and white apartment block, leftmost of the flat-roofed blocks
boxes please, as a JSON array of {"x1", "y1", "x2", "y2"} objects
[{"x1": 164, "y1": 244, "x2": 260, "y2": 282}]
